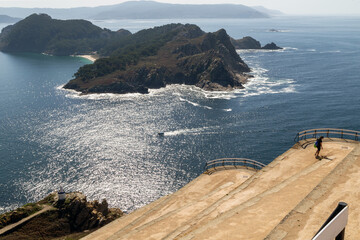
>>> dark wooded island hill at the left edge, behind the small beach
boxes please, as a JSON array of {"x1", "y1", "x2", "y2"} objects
[{"x1": 0, "y1": 14, "x2": 131, "y2": 55}]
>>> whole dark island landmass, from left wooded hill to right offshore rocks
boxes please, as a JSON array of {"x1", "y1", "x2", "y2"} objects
[{"x1": 0, "y1": 14, "x2": 277, "y2": 94}]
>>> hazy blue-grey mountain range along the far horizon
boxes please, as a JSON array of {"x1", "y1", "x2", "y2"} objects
[{"x1": 0, "y1": 1, "x2": 279, "y2": 20}]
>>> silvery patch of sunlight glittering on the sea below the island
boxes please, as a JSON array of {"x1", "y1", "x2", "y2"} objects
[{"x1": 14, "y1": 93, "x2": 195, "y2": 211}]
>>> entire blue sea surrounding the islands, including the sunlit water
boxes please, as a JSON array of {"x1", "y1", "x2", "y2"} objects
[{"x1": 0, "y1": 16, "x2": 360, "y2": 212}]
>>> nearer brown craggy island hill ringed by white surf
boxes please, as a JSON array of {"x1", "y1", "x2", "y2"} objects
[{"x1": 65, "y1": 24, "x2": 250, "y2": 93}]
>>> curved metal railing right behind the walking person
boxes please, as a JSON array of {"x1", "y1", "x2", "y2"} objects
[{"x1": 294, "y1": 128, "x2": 360, "y2": 142}]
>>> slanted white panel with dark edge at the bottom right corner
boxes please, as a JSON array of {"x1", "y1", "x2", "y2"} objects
[{"x1": 312, "y1": 202, "x2": 349, "y2": 240}]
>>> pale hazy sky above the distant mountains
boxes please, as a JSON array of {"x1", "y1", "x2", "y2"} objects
[{"x1": 0, "y1": 0, "x2": 360, "y2": 15}]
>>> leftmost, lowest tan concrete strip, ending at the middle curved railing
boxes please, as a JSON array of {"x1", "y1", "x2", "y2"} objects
[{"x1": 83, "y1": 169, "x2": 255, "y2": 240}]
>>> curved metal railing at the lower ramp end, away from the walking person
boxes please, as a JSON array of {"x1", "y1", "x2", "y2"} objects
[{"x1": 204, "y1": 158, "x2": 266, "y2": 174}]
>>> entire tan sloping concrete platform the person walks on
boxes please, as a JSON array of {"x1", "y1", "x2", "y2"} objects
[{"x1": 83, "y1": 138, "x2": 360, "y2": 240}]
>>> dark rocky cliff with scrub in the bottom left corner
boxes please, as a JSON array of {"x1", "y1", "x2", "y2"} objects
[{"x1": 0, "y1": 192, "x2": 123, "y2": 240}]
